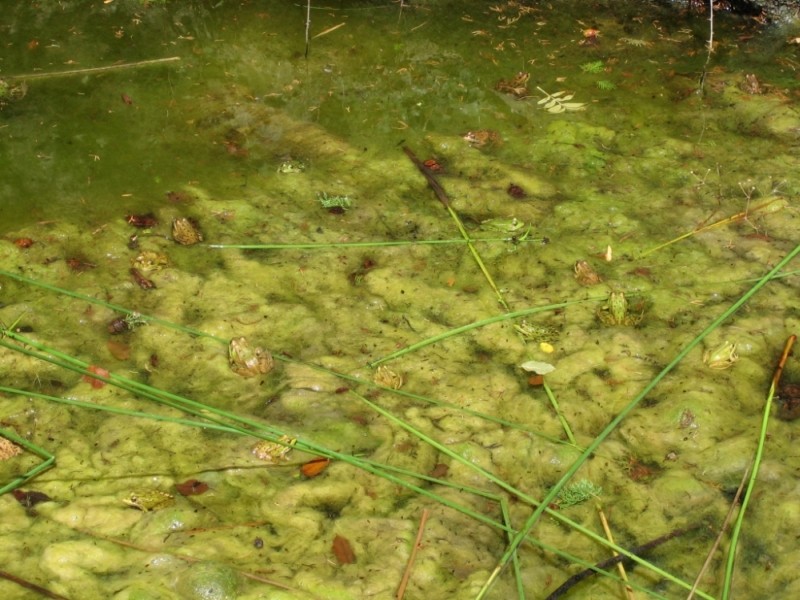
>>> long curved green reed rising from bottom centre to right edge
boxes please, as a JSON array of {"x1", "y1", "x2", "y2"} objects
[{"x1": 476, "y1": 245, "x2": 800, "y2": 600}]
